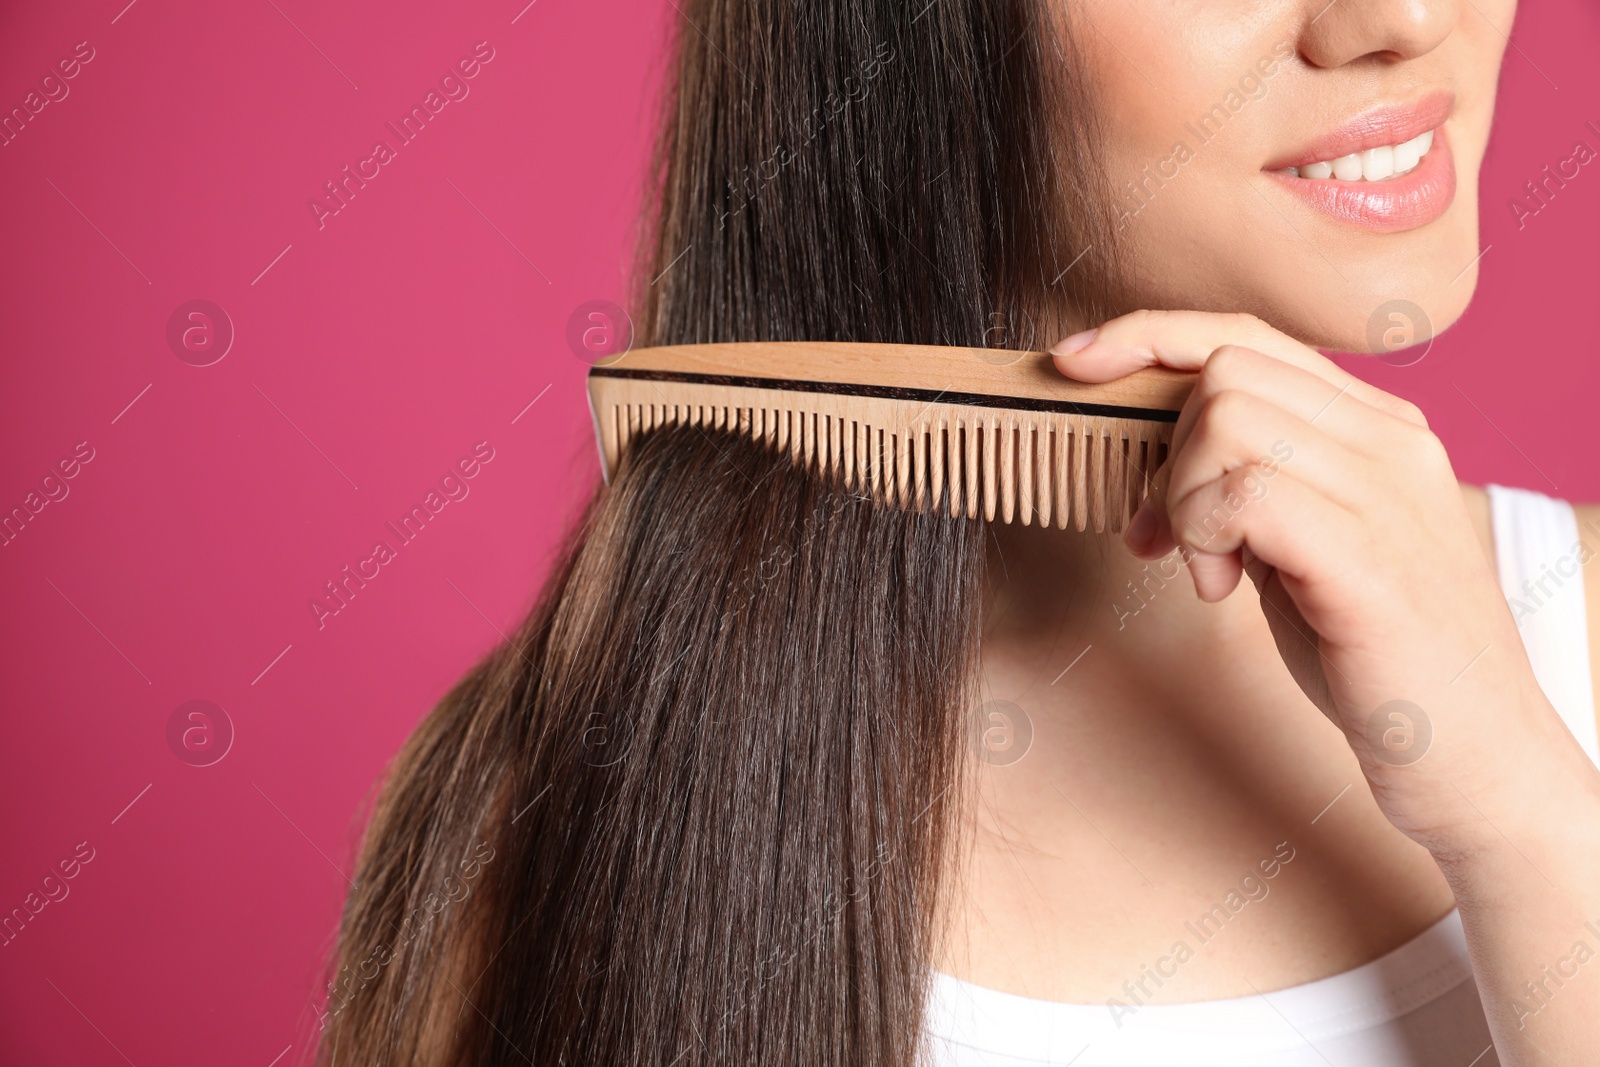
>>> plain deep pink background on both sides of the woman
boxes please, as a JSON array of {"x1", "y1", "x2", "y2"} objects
[{"x1": 0, "y1": 0, "x2": 1600, "y2": 1067}]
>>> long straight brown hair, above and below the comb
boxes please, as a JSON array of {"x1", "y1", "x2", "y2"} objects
[{"x1": 318, "y1": 0, "x2": 1117, "y2": 1067}]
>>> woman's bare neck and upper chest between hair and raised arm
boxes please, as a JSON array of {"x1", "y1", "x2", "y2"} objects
[{"x1": 936, "y1": 525, "x2": 1451, "y2": 1003}]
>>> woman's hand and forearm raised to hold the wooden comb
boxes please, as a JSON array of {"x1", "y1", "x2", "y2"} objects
[{"x1": 1051, "y1": 312, "x2": 1600, "y2": 1065}]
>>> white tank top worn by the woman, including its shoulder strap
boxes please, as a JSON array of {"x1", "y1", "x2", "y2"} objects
[{"x1": 926, "y1": 485, "x2": 1600, "y2": 1067}]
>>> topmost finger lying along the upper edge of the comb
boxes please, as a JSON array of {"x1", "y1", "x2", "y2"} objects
[{"x1": 1050, "y1": 310, "x2": 1426, "y2": 424}]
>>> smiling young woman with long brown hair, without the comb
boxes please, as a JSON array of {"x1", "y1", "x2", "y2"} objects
[{"x1": 312, "y1": 0, "x2": 1600, "y2": 1067}]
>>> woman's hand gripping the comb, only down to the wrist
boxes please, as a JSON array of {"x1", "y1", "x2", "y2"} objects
[{"x1": 1053, "y1": 312, "x2": 1595, "y2": 848}]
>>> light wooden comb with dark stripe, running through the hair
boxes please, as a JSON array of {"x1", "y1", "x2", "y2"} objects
[{"x1": 589, "y1": 341, "x2": 1195, "y2": 531}]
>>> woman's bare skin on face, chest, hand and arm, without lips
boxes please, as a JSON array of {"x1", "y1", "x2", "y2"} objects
[{"x1": 938, "y1": 0, "x2": 1600, "y2": 1067}]
